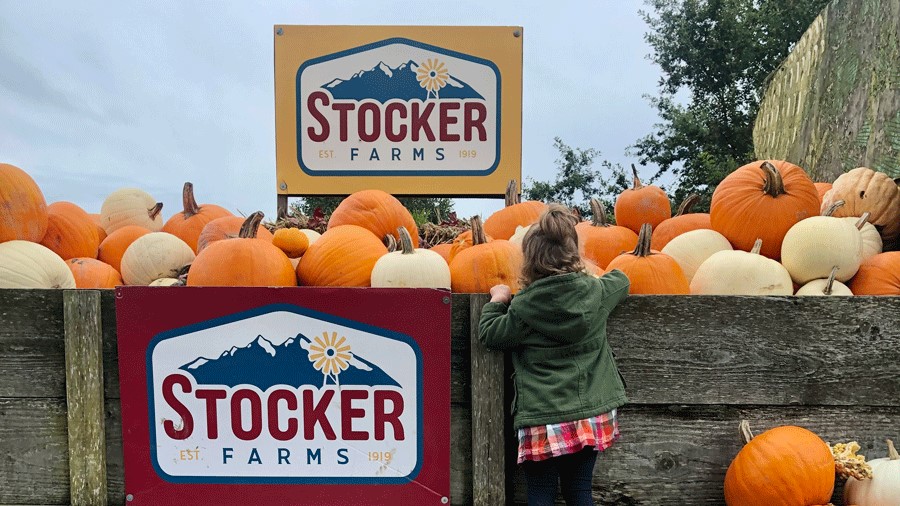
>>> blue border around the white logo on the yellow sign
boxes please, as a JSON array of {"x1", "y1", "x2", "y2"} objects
[{"x1": 295, "y1": 37, "x2": 503, "y2": 176}]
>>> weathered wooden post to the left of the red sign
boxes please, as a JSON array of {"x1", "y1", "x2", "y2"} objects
[{"x1": 63, "y1": 290, "x2": 106, "y2": 506}]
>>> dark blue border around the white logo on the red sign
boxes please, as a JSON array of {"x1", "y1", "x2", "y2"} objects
[{"x1": 146, "y1": 303, "x2": 424, "y2": 485}]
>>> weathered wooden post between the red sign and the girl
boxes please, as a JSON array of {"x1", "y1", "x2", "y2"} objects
[{"x1": 469, "y1": 294, "x2": 506, "y2": 506}]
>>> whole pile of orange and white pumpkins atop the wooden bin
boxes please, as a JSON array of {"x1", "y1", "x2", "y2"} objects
[{"x1": 0, "y1": 160, "x2": 900, "y2": 295}]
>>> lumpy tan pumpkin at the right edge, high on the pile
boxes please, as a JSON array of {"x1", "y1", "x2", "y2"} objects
[{"x1": 822, "y1": 167, "x2": 900, "y2": 249}]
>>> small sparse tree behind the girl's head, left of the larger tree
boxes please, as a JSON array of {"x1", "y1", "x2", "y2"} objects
[{"x1": 522, "y1": 137, "x2": 630, "y2": 218}]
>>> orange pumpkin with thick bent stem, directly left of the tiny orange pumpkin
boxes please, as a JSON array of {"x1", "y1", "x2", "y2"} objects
[{"x1": 187, "y1": 211, "x2": 297, "y2": 286}]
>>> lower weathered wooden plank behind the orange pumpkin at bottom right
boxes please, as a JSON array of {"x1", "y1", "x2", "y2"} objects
[{"x1": 510, "y1": 405, "x2": 900, "y2": 506}]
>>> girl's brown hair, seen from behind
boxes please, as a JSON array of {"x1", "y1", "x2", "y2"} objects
[{"x1": 519, "y1": 204, "x2": 584, "y2": 288}]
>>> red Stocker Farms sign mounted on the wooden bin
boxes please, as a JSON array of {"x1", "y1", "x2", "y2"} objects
[{"x1": 116, "y1": 287, "x2": 451, "y2": 505}]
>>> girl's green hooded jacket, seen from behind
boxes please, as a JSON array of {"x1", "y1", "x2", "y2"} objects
[{"x1": 479, "y1": 270, "x2": 629, "y2": 429}]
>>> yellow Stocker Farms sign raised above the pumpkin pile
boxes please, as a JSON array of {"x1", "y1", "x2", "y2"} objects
[{"x1": 275, "y1": 26, "x2": 522, "y2": 196}]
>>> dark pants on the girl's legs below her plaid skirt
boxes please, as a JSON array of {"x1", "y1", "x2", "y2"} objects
[{"x1": 522, "y1": 447, "x2": 597, "y2": 506}]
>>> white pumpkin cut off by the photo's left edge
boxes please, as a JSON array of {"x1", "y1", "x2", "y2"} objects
[{"x1": 0, "y1": 240, "x2": 75, "y2": 288}]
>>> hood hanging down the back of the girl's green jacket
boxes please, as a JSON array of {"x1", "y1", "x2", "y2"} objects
[{"x1": 509, "y1": 272, "x2": 601, "y2": 342}]
